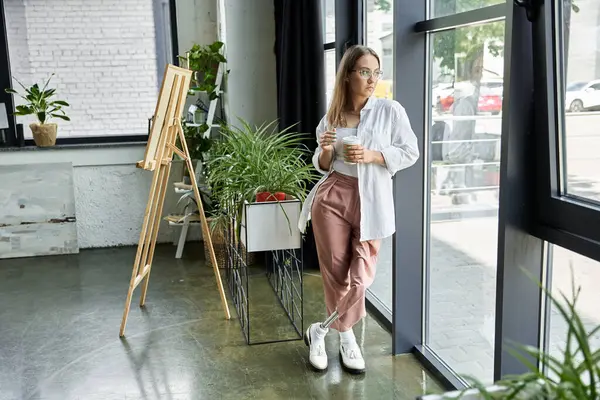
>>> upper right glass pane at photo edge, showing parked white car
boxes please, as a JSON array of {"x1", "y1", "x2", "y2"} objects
[{"x1": 560, "y1": 0, "x2": 600, "y2": 201}]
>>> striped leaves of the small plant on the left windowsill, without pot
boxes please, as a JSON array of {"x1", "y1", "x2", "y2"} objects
[{"x1": 5, "y1": 74, "x2": 70, "y2": 124}]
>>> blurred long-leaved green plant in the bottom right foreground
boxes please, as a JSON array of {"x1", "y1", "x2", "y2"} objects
[{"x1": 420, "y1": 264, "x2": 600, "y2": 400}]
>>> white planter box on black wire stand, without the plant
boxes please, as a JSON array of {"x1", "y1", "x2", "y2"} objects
[{"x1": 240, "y1": 199, "x2": 302, "y2": 253}]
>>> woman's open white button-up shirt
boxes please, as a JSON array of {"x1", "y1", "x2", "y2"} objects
[{"x1": 298, "y1": 97, "x2": 419, "y2": 241}]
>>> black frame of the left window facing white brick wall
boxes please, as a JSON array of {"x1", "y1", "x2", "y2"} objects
[{"x1": 0, "y1": 0, "x2": 179, "y2": 148}]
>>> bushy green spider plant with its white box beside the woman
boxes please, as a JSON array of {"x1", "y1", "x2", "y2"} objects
[{"x1": 208, "y1": 119, "x2": 318, "y2": 251}]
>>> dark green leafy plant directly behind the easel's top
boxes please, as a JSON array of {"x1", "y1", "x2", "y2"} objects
[{"x1": 179, "y1": 41, "x2": 227, "y2": 100}]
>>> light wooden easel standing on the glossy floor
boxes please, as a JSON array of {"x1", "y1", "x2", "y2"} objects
[{"x1": 119, "y1": 64, "x2": 231, "y2": 337}]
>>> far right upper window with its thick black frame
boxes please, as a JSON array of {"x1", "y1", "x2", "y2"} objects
[{"x1": 535, "y1": 0, "x2": 600, "y2": 248}]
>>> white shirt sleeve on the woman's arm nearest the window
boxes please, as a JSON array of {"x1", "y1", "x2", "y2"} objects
[{"x1": 381, "y1": 103, "x2": 419, "y2": 176}]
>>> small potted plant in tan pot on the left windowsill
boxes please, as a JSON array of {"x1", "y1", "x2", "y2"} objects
[{"x1": 5, "y1": 74, "x2": 70, "y2": 147}]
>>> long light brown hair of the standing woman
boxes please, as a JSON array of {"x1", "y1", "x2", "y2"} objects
[{"x1": 327, "y1": 45, "x2": 381, "y2": 128}]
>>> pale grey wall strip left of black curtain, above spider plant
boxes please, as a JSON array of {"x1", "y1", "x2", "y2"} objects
[{"x1": 224, "y1": 0, "x2": 277, "y2": 125}]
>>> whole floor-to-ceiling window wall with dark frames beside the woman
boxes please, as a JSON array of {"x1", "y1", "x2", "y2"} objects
[{"x1": 363, "y1": 0, "x2": 600, "y2": 387}]
